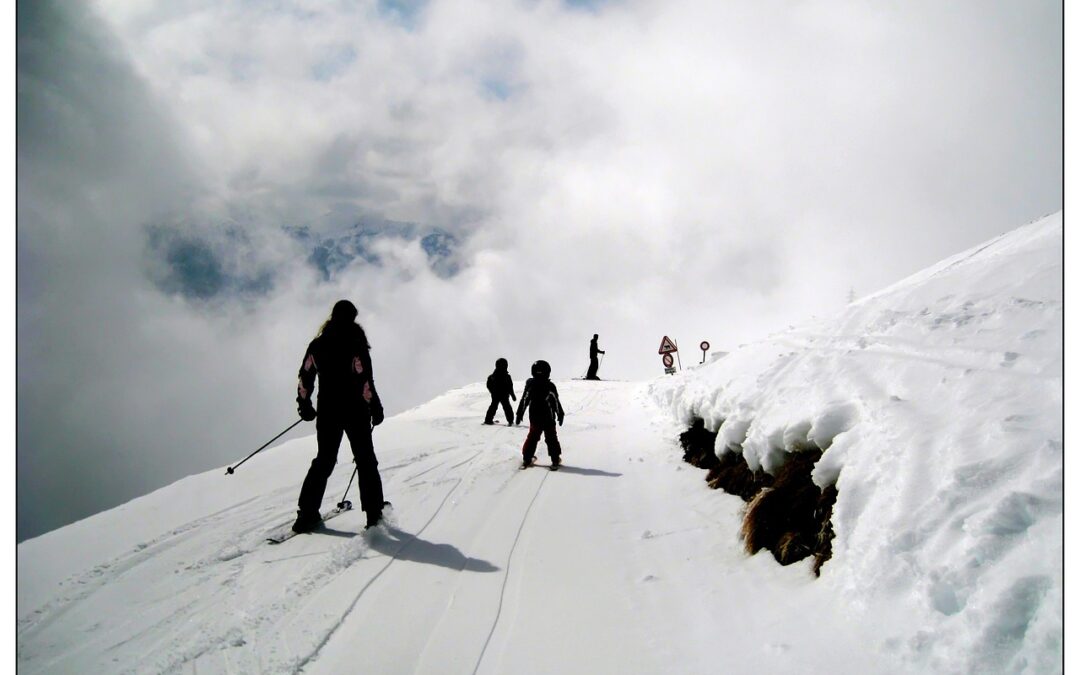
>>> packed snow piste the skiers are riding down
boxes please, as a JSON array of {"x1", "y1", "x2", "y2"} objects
[{"x1": 17, "y1": 381, "x2": 888, "y2": 674}]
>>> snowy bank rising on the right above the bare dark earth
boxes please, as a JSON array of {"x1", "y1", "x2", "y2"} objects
[{"x1": 651, "y1": 213, "x2": 1064, "y2": 673}]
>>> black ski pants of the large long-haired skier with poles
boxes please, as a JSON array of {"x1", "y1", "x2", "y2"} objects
[{"x1": 298, "y1": 415, "x2": 382, "y2": 517}]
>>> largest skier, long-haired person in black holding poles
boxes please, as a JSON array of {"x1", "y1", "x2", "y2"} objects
[{"x1": 293, "y1": 300, "x2": 383, "y2": 532}]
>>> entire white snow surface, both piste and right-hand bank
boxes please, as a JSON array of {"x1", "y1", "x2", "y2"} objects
[{"x1": 16, "y1": 214, "x2": 1064, "y2": 674}]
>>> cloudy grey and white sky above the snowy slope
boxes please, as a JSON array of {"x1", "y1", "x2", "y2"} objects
[{"x1": 16, "y1": 0, "x2": 1062, "y2": 540}]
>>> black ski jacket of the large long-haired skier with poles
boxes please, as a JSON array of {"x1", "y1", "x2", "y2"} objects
[{"x1": 296, "y1": 324, "x2": 382, "y2": 424}]
